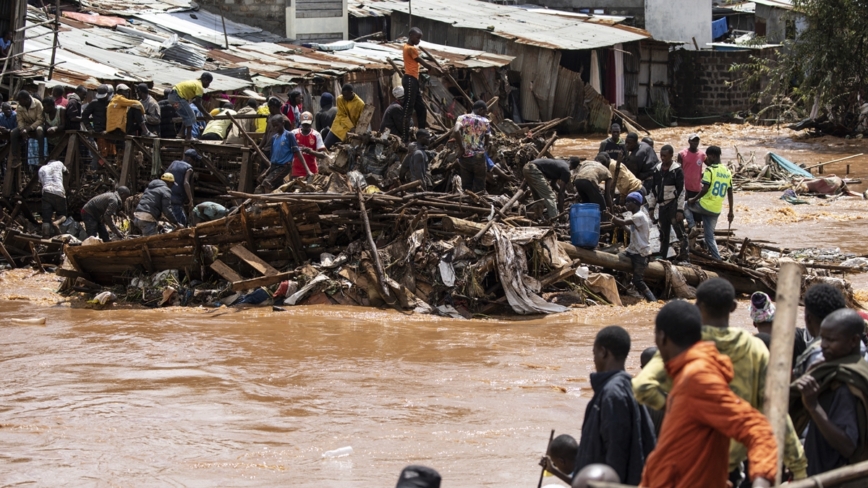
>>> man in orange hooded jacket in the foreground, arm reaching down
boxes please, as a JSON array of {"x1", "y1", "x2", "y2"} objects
[{"x1": 641, "y1": 301, "x2": 777, "y2": 488}]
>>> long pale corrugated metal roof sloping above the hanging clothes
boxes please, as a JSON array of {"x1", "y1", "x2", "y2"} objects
[{"x1": 355, "y1": 0, "x2": 651, "y2": 50}]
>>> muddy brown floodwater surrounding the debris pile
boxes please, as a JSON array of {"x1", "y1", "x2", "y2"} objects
[{"x1": 0, "y1": 126, "x2": 868, "y2": 488}]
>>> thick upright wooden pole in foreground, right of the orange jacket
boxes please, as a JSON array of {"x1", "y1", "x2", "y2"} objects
[{"x1": 763, "y1": 263, "x2": 802, "y2": 484}]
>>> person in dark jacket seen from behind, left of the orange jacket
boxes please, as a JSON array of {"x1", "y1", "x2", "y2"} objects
[{"x1": 543, "y1": 325, "x2": 656, "y2": 485}]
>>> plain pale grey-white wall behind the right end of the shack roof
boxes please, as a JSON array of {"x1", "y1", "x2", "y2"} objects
[{"x1": 645, "y1": 0, "x2": 712, "y2": 50}]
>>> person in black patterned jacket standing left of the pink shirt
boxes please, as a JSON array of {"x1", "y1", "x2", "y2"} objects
[{"x1": 648, "y1": 144, "x2": 688, "y2": 261}]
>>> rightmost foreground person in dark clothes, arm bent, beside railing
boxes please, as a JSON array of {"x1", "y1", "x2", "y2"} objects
[{"x1": 790, "y1": 309, "x2": 868, "y2": 478}]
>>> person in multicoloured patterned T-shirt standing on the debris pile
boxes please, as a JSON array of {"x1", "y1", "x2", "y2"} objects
[{"x1": 450, "y1": 100, "x2": 491, "y2": 193}]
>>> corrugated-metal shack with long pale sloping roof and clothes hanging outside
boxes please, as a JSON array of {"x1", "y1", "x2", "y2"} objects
[{"x1": 350, "y1": 0, "x2": 670, "y2": 129}]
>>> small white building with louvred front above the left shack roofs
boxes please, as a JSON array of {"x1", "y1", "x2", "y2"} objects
[{"x1": 286, "y1": 0, "x2": 349, "y2": 42}]
